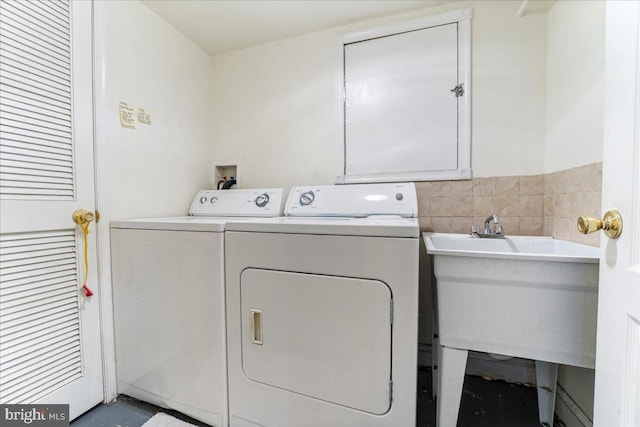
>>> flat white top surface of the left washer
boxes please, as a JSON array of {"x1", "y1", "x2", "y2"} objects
[{"x1": 111, "y1": 216, "x2": 230, "y2": 233}]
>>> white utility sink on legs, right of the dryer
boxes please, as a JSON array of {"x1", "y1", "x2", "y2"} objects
[{"x1": 423, "y1": 233, "x2": 599, "y2": 427}]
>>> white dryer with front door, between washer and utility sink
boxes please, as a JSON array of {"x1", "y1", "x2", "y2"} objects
[{"x1": 225, "y1": 184, "x2": 419, "y2": 427}]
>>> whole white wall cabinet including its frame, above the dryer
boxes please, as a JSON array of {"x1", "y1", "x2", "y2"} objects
[{"x1": 336, "y1": 9, "x2": 471, "y2": 183}]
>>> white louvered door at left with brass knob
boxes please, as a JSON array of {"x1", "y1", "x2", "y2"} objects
[{"x1": 0, "y1": 0, "x2": 103, "y2": 418}]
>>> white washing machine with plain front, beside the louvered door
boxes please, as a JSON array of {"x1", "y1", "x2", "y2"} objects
[{"x1": 111, "y1": 189, "x2": 284, "y2": 427}]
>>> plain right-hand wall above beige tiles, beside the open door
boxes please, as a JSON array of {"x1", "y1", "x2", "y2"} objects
[{"x1": 544, "y1": 1, "x2": 605, "y2": 172}]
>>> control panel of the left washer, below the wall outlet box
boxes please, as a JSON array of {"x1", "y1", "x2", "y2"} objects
[{"x1": 189, "y1": 188, "x2": 284, "y2": 217}]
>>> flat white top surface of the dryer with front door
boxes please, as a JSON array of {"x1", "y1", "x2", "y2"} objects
[{"x1": 227, "y1": 217, "x2": 420, "y2": 238}]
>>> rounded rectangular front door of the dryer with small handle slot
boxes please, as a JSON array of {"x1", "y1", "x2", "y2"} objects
[{"x1": 240, "y1": 268, "x2": 392, "y2": 414}]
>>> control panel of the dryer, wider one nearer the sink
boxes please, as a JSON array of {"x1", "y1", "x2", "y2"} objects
[{"x1": 285, "y1": 182, "x2": 418, "y2": 218}]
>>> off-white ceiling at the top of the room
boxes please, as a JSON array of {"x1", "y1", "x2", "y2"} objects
[{"x1": 143, "y1": 0, "x2": 452, "y2": 55}]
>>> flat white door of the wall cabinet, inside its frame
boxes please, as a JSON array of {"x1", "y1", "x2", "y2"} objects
[{"x1": 345, "y1": 24, "x2": 458, "y2": 175}]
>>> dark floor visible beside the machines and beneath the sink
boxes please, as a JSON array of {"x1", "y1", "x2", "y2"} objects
[{"x1": 71, "y1": 368, "x2": 552, "y2": 427}]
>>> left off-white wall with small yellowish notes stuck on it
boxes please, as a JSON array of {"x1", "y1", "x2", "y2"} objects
[{"x1": 96, "y1": 1, "x2": 214, "y2": 219}]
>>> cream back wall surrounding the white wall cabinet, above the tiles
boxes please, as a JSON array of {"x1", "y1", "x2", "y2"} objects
[{"x1": 211, "y1": 1, "x2": 546, "y2": 191}]
